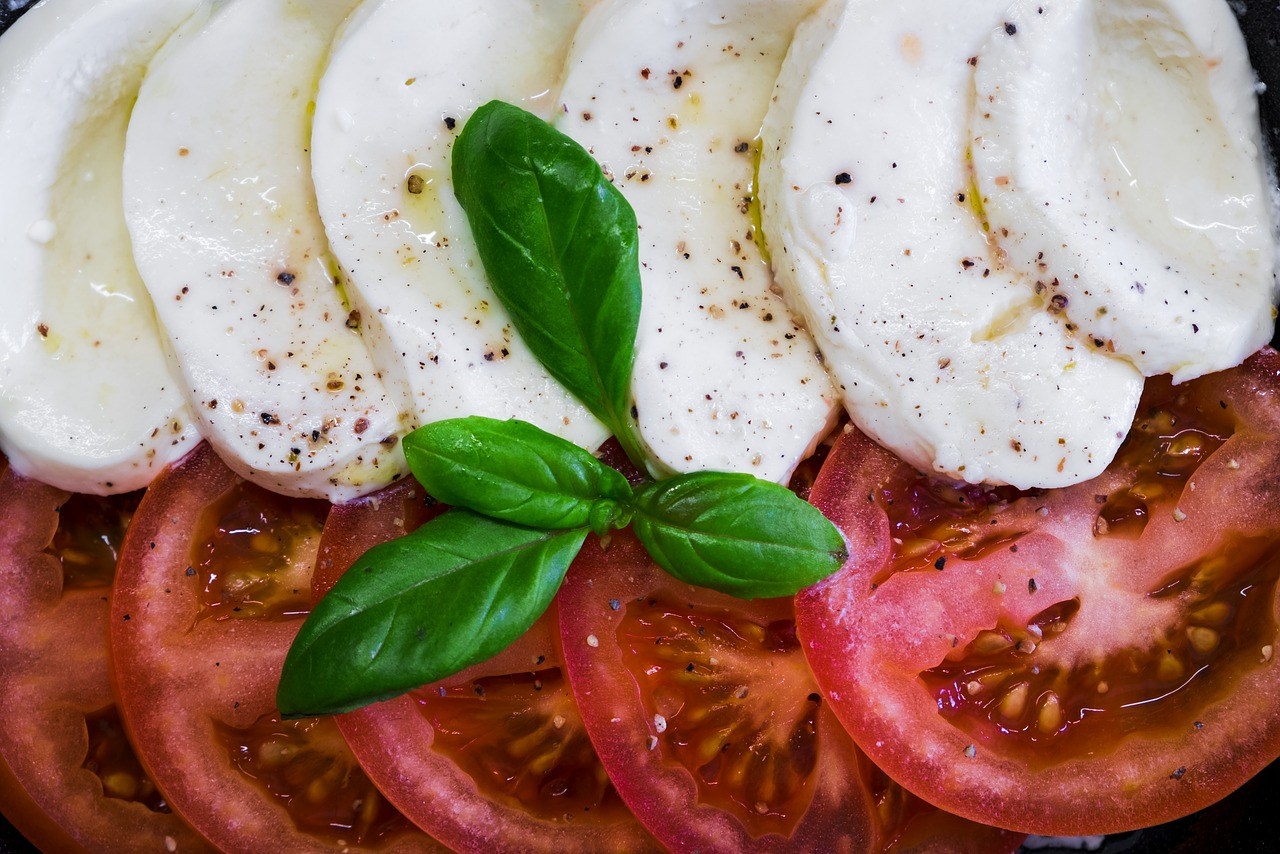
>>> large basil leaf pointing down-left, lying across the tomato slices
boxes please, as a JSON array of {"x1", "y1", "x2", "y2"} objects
[{"x1": 276, "y1": 510, "x2": 586, "y2": 717}]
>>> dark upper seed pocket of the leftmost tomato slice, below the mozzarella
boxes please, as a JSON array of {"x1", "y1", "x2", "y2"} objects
[{"x1": 46, "y1": 492, "x2": 142, "y2": 590}]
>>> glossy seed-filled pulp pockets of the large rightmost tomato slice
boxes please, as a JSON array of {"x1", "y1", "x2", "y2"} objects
[{"x1": 879, "y1": 378, "x2": 1277, "y2": 767}]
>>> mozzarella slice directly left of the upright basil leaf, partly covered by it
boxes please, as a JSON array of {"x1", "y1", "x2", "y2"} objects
[{"x1": 312, "y1": 0, "x2": 608, "y2": 449}]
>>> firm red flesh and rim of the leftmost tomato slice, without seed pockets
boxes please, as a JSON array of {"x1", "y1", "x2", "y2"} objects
[{"x1": 0, "y1": 458, "x2": 206, "y2": 851}]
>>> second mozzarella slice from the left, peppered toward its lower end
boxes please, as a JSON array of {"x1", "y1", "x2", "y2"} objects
[{"x1": 124, "y1": 0, "x2": 407, "y2": 501}]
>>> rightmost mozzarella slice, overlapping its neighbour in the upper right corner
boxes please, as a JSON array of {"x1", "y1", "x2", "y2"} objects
[{"x1": 973, "y1": 0, "x2": 1276, "y2": 382}]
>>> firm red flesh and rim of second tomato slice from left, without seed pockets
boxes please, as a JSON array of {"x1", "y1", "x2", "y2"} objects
[{"x1": 110, "y1": 444, "x2": 439, "y2": 851}]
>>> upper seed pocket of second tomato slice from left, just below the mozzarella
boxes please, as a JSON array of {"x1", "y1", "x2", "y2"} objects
[{"x1": 191, "y1": 481, "x2": 329, "y2": 620}]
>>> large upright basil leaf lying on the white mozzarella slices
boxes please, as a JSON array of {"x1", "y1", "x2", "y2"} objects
[{"x1": 453, "y1": 101, "x2": 646, "y2": 465}]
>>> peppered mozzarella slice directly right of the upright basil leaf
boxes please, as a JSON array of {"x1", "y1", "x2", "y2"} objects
[{"x1": 558, "y1": 0, "x2": 837, "y2": 480}]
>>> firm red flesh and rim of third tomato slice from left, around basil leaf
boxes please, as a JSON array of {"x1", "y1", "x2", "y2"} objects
[{"x1": 312, "y1": 483, "x2": 658, "y2": 854}]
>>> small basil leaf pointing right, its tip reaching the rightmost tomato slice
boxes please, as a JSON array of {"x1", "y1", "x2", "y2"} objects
[{"x1": 632, "y1": 471, "x2": 849, "y2": 599}]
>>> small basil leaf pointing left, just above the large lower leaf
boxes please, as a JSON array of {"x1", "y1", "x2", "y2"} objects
[{"x1": 404, "y1": 417, "x2": 631, "y2": 535}]
